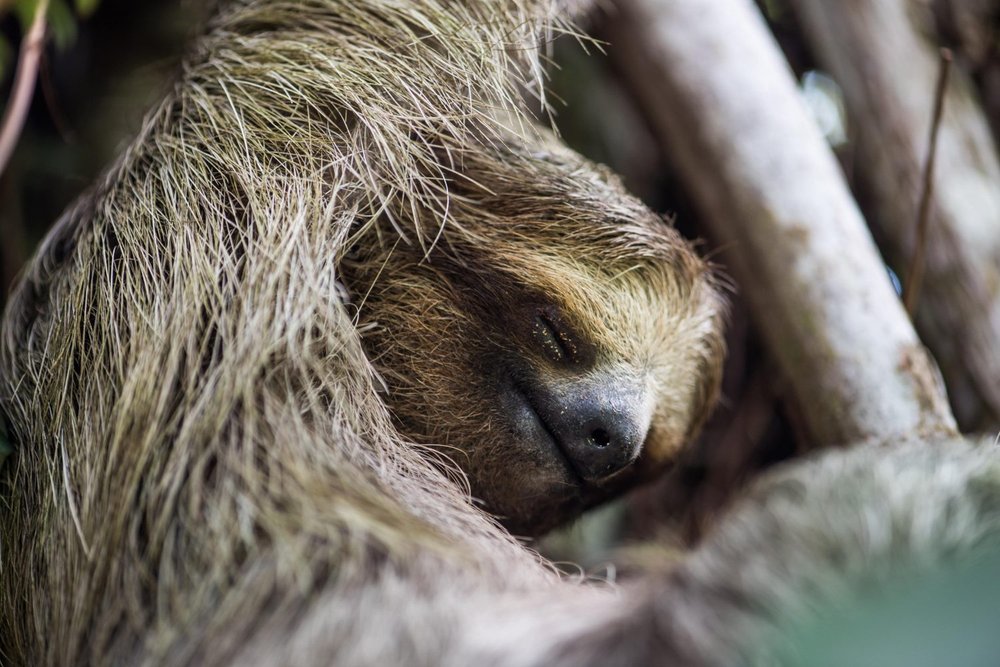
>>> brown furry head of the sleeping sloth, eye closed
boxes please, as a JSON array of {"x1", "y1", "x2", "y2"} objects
[{"x1": 343, "y1": 144, "x2": 723, "y2": 534}]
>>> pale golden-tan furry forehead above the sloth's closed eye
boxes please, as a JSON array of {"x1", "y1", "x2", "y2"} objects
[{"x1": 442, "y1": 212, "x2": 715, "y2": 352}]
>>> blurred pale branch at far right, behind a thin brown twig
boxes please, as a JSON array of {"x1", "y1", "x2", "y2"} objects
[{"x1": 794, "y1": 0, "x2": 1000, "y2": 425}]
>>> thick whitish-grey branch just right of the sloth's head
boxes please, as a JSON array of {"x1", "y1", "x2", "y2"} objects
[{"x1": 611, "y1": 0, "x2": 955, "y2": 444}]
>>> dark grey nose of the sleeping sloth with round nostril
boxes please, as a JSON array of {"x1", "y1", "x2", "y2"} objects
[{"x1": 537, "y1": 374, "x2": 651, "y2": 483}]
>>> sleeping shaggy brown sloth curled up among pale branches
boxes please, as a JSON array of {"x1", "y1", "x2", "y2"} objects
[{"x1": 0, "y1": 0, "x2": 1000, "y2": 666}]
